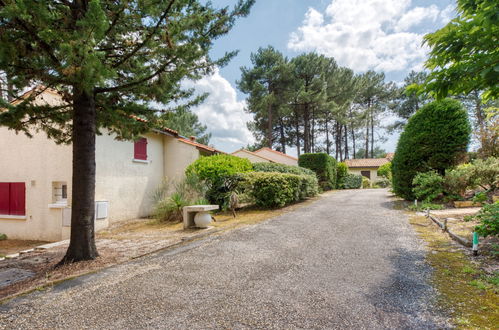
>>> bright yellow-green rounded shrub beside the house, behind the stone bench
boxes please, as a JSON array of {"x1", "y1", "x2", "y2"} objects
[{"x1": 185, "y1": 154, "x2": 253, "y2": 183}]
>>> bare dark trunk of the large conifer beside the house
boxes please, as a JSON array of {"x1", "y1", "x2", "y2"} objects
[{"x1": 60, "y1": 88, "x2": 98, "y2": 264}]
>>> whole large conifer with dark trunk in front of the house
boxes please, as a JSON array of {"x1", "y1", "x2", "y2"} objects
[{"x1": 0, "y1": 0, "x2": 254, "y2": 262}]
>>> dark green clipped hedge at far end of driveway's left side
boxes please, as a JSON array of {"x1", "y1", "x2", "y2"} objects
[{"x1": 298, "y1": 153, "x2": 336, "y2": 190}]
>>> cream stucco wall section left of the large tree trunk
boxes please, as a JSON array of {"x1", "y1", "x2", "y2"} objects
[{"x1": 0, "y1": 127, "x2": 72, "y2": 241}]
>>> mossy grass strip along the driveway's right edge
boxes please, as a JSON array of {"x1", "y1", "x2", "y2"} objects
[{"x1": 410, "y1": 217, "x2": 499, "y2": 329}]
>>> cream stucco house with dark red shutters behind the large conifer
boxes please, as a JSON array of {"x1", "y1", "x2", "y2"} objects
[{"x1": 0, "y1": 90, "x2": 223, "y2": 241}]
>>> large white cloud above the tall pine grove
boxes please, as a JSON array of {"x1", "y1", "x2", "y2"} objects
[{"x1": 288, "y1": 0, "x2": 451, "y2": 72}]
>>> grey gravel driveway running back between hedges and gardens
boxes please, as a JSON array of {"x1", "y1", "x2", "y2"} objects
[{"x1": 0, "y1": 189, "x2": 450, "y2": 329}]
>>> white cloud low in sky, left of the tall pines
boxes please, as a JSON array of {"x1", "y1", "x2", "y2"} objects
[{"x1": 185, "y1": 70, "x2": 254, "y2": 152}]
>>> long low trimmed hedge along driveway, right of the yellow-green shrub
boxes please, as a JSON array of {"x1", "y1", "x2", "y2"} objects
[{"x1": 244, "y1": 172, "x2": 318, "y2": 207}]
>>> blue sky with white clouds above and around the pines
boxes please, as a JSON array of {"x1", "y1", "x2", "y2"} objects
[{"x1": 189, "y1": 0, "x2": 455, "y2": 154}]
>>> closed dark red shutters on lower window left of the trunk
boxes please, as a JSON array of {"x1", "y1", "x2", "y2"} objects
[{"x1": 0, "y1": 182, "x2": 26, "y2": 215}]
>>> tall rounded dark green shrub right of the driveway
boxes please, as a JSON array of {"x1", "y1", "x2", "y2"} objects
[{"x1": 392, "y1": 99, "x2": 471, "y2": 200}]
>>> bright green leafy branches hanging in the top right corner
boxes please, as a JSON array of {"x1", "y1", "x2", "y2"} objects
[{"x1": 425, "y1": 0, "x2": 499, "y2": 99}]
